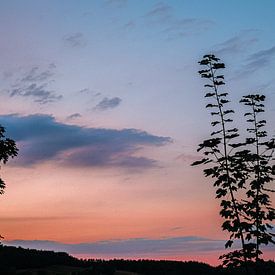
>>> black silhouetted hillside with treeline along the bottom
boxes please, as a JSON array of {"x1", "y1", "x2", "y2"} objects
[{"x1": 0, "y1": 246, "x2": 275, "y2": 275}]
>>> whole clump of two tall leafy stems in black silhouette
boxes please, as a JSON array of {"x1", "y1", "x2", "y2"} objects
[{"x1": 192, "y1": 54, "x2": 275, "y2": 273}]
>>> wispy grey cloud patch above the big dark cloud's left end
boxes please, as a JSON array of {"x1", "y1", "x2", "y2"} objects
[{"x1": 8, "y1": 64, "x2": 62, "y2": 104}]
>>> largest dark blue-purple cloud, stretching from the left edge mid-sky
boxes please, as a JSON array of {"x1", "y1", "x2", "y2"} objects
[{"x1": 0, "y1": 115, "x2": 171, "y2": 169}]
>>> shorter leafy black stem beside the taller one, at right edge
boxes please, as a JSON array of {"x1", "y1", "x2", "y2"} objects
[{"x1": 240, "y1": 94, "x2": 275, "y2": 261}]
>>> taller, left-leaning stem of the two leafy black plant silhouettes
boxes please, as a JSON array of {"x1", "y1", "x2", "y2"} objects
[{"x1": 192, "y1": 54, "x2": 249, "y2": 266}]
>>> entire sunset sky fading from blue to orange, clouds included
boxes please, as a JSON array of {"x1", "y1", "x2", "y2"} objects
[{"x1": 0, "y1": 0, "x2": 275, "y2": 264}]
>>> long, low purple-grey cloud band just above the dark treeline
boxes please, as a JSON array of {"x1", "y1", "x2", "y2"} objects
[{"x1": 4, "y1": 236, "x2": 224, "y2": 258}]
